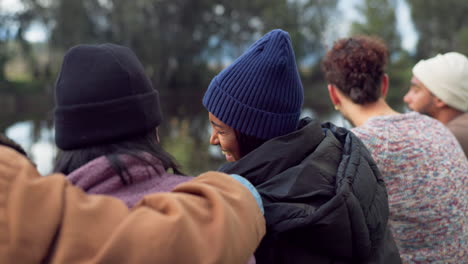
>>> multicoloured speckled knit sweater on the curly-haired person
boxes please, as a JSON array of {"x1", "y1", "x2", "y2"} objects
[{"x1": 352, "y1": 112, "x2": 468, "y2": 263}]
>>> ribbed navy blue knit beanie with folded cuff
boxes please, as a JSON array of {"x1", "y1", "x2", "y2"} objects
[{"x1": 203, "y1": 29, "x2": 304, "y2": 139}]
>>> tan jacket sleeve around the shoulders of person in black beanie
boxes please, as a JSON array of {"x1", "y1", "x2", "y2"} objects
[{"x1": 0, "y1": 147, "x2": 265, "y2": 264}]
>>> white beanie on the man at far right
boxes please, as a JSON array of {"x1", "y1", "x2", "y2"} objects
[{"x1": 413, "y1": 52, "x2": 468, "y2": 112}]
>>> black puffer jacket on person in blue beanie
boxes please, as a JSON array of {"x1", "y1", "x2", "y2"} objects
[{"x1": 220, "y1": 119, "x2": 401, "y2": 264}]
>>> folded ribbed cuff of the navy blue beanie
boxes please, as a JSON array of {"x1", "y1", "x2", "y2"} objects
[{"x1": 203, "y1": 77, "x2": 300, "y2": 139}]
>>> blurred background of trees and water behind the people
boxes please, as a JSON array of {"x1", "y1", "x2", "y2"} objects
[{"x1": 0, "y1": 0, "x2": 468, "y2": 173}]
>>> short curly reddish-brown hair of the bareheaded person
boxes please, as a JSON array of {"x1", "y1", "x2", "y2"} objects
[{"x1": 322, "y1": 36, "x2": 388, "y2": 104}]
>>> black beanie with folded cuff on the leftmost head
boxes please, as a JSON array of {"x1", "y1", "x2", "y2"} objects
[{"x1": 54, "y1": 44, "x2": 162, "y2": 150}]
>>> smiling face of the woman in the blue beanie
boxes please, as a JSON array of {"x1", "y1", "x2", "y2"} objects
[{"x1": 208, "y1": 113, "x2": 241, "y2": 162}]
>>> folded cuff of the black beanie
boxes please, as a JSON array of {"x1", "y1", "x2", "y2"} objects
[{"x1": 55, "y1": 91, "x2": 162, "y2": 150}]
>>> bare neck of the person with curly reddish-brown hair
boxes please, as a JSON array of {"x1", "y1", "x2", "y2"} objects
[{"x1": 343, "y1": 98, "x2": 399, "y2": 126}]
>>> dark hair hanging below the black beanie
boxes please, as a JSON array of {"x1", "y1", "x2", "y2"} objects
[{"x1": 54, "y1": 131, "x2": 183, "y2": 185}]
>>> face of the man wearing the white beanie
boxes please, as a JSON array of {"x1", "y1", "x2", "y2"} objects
[{"x1": 403, "y1": 76, "x2": 435, "y2": 116}]
